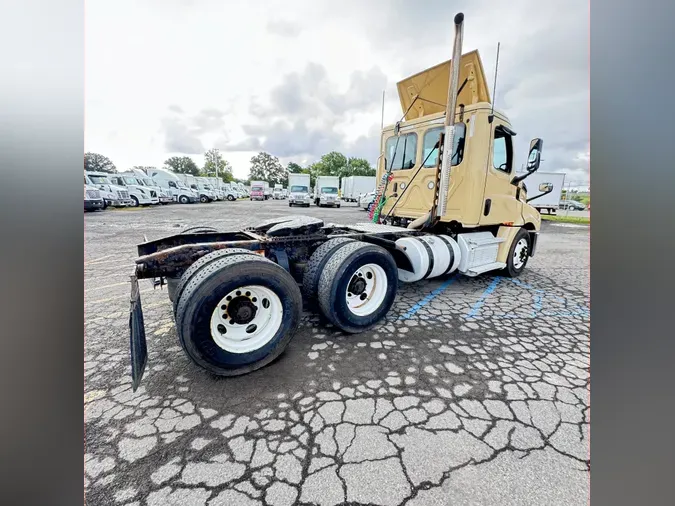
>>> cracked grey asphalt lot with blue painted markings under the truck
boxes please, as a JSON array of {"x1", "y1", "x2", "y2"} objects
[{"x1": 84, "y1": 201, "x2": 590, "y2": 506}]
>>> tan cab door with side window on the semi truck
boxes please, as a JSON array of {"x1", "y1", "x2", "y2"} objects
[{"x1": 479, "y1": 121, "x2": 522, "y2": 225}]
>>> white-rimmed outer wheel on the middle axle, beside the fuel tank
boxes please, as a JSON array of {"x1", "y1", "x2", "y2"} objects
[{"x1": 318, "y1": 241, "x2": 398, "y2": 334}]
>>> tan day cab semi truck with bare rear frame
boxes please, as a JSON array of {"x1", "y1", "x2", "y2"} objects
[{"x1": 129, "y1": 13, "x2": 550, "y2": 390}]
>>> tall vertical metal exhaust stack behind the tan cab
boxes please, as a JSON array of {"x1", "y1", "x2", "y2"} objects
[{"x1": 436, "y1": 12, "x2": 464, "y2": 217}]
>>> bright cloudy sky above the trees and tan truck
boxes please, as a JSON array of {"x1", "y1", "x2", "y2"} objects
[{"x1": 85, "y1": 0, "x2": 590, "y2": 186}]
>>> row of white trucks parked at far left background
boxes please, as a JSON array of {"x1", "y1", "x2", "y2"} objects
[{"x1": 84, "y1": 168, "x2": 249, "y2": 211}]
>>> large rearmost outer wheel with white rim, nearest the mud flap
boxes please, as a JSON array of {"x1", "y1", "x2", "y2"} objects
[{"x1": 176, "y1": 254, "x2": 302, "y2": 376}]
